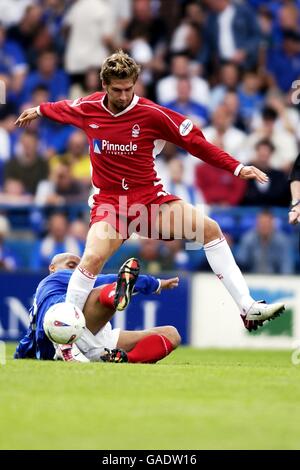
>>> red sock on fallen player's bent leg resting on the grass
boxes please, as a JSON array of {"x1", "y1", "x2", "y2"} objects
[{"x1": 127, "y1": 334, "x2": 174, "y2": 363}]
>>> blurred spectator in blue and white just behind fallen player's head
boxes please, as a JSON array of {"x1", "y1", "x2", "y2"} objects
[{"x1": 31, "y1": 213, "x2": 80, "y2": 269}]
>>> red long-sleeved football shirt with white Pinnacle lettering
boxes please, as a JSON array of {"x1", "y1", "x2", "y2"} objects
[{"x1": 40, "y1": 92, "x2": 240, "y2": 192}]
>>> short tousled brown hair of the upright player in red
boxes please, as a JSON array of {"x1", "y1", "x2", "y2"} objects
[{"x1": 100, "y1": 50, "x2": 141, "y2": 85}]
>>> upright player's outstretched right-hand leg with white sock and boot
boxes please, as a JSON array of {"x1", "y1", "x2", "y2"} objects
[{"x1": 157, "y1": 201, "x2": 284, "y2": 329}]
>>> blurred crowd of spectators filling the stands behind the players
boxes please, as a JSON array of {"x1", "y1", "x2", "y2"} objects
[{"x1": 0, "y1": 0, "x2": 300, "y2": 273}]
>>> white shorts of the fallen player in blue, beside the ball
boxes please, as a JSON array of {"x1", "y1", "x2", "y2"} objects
[{"x1": 76, "y1": 322, "x2": 120, "y2": 362}]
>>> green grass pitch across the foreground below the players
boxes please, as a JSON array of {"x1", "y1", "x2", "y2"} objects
[{"x1": 0, "y1": 345, "x2": 300, "y2": 450}]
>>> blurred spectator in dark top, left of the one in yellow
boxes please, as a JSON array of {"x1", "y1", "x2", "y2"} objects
[{"x1": 4, "y1": 130, "x2": 48, "y2": 195}]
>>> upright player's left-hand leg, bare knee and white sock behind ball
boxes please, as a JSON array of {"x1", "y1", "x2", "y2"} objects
[{"x1": 66, "y1": 221, "x2": 123, "y2": 310}]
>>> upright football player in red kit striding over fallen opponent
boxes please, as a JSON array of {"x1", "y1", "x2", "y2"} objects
[{"x1": 16, "y1": 51, "x2": 284, "y2": 330}]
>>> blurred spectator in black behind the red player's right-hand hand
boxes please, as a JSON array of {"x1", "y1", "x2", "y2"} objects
[{"x1": 242, "y1": 139, "x2": 290, "y2": 207}]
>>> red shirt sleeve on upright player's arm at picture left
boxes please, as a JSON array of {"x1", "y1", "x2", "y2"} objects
[{"x1": 40, "y1": 98, "x2": 84, "y2": 129}]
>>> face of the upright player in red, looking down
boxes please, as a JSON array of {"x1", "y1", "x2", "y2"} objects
[{"x1": 103, "y1": 79, "x2": 134, "y2": 113}]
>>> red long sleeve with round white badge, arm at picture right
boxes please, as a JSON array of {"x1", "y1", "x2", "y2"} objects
[{"x1": 152, "y1": 105, "x2": 240, "y2": 173}]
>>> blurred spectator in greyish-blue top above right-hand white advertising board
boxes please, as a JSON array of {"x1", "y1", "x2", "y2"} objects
[{"x1": 236, "y1": 211, "x2": 294, "y2": 274}]
